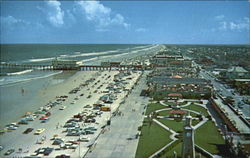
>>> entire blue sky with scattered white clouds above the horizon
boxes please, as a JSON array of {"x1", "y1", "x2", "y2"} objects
[{"x1": 0, "y1": 0, "x2": 250, "y2": 44}]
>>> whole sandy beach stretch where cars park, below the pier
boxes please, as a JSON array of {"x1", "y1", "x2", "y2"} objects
[{"x1": 0, "y1": 71, "x2": 141, "y2": 157}]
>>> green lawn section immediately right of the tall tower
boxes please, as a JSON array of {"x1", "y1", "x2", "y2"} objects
[{"x1": 195, "y1": 121, "x2": 225, "y2": 154}]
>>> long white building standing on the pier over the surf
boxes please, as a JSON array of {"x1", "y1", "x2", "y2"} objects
[{"x1": 52, "y1": 58, "x2": 79, "y2": 70}]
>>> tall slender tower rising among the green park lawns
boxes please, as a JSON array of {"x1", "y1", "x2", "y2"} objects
[{"x1": 181, "y1": 115, "x2": 195, "y2": 158}]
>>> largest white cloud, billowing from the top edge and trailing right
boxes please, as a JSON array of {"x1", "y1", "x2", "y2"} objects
[{"x1": 76, "y1": 1, "x2": 130, "y2": 31}]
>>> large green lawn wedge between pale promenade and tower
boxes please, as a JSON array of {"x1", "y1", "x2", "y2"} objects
[{"x1": 135, "y1": 119, "x2": 171, "y2": 158}]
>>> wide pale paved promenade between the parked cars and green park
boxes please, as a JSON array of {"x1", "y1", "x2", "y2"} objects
[{"x1": 85, "y1": 71, "x2": 148, "y2": 158}]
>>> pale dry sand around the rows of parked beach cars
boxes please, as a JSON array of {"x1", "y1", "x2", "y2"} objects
[{"x1": 0, "y1": 71, "x2": 140, "y2": 157}]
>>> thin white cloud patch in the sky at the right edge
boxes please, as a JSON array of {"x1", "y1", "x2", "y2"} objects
[{"x1": 214, "y1": 17, "x2": 250, "y2": 31}]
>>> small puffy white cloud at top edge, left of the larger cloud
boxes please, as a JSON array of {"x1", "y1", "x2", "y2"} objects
[{"x1": 46, "y1": 0, "x2": 64, "y2": 27}]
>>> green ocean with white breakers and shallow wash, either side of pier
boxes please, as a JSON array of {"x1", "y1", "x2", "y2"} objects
[{"x1": 0, "y1": 44, "x2": 162, "y2": 128}]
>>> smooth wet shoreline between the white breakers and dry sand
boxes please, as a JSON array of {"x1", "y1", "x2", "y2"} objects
[{"x1": 0, "y1": 71, "x2": 75, "y2": 129}]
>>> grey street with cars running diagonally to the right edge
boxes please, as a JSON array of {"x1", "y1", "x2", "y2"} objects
[{"x1": 200, "y1": 70, "x2": 250, "y2": 117}]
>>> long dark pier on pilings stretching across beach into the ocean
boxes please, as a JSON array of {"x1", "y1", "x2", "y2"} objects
[{"x1": 0, "y1": 63, "x2": 143, "y2": 71}]
